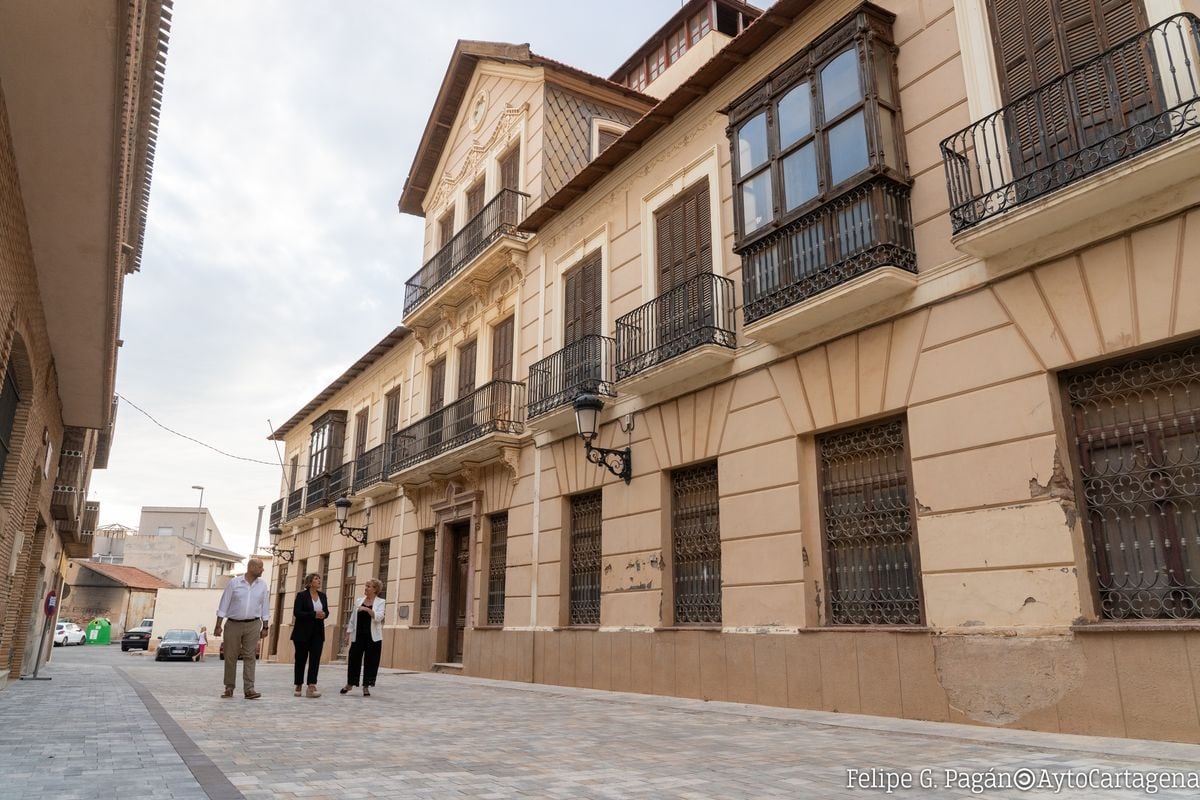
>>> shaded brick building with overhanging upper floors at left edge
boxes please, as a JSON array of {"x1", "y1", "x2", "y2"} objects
[{"x1": 0, "y1": 0, "x2": 170, "y2": 686}]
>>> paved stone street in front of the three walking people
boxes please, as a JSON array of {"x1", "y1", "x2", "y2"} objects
[{"x1": 0, "y1": 646, "x2": 1200, "y2": 800}]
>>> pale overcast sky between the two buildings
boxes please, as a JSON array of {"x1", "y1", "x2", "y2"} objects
[{"x1": 91, "y1": 0, "x2": 680, "y2": 563}]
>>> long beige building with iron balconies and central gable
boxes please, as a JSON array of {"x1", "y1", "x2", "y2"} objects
[{"x1": 271, "y1": 0, "x2": 1200, "y2": 741}]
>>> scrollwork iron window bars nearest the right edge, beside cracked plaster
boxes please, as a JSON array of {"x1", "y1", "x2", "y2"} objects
[{"x1": 1064, "y1": 343, "x2": 1200, "y2": 619}]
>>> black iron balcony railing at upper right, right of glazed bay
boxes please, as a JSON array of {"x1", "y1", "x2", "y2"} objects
[{"x1": 942, "y1": 13, "x2": 1200, "y2": 233}]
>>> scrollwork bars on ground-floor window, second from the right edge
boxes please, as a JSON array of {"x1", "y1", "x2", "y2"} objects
[{"x1": 817, "y1": 420, "x2": 922, "y2": 625}]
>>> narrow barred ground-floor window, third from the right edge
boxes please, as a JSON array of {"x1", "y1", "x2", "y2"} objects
[{"x1": 671, "y1": 462, "x2": 721, "y2": 625}]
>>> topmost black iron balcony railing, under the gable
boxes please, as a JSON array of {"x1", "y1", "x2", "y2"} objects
[{"x1": 404, "y1": 188, "x2": 529, "y2": 314}]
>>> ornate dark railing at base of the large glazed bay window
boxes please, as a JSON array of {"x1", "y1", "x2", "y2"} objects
[{"x1": 740, "y1": 176, "x2": 917, "y2": 325}]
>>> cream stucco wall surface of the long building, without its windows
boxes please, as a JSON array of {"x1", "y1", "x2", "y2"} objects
[{"x1": 272, "y1": 0, "x2": 1200, "y2": 741}]
